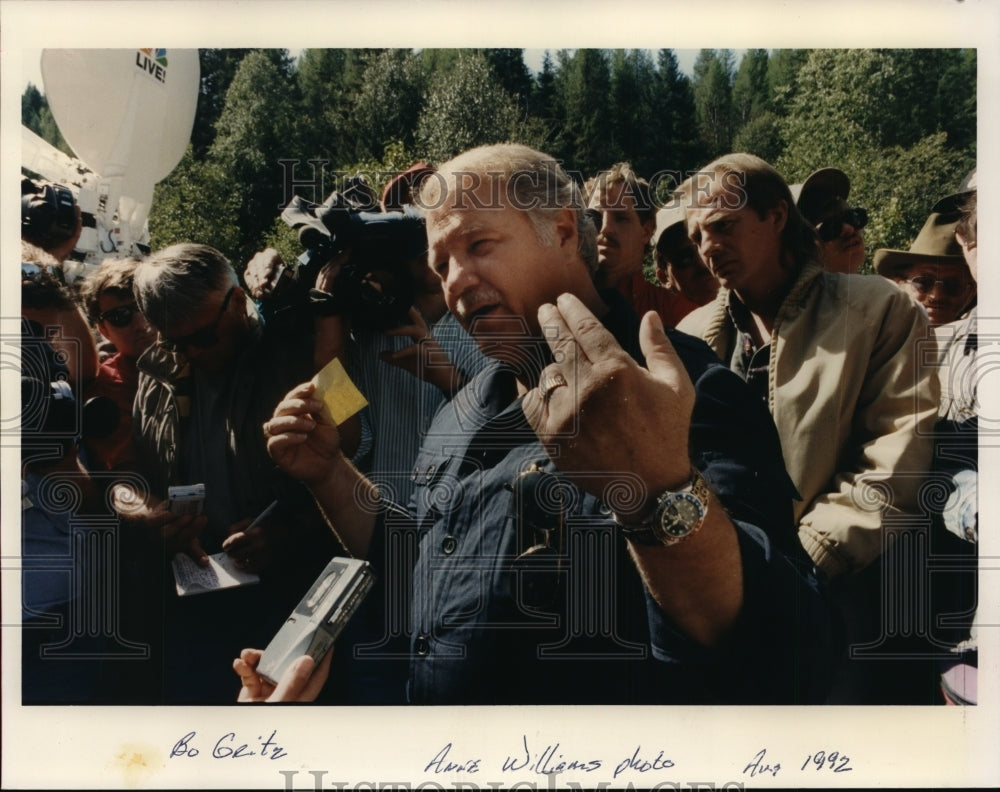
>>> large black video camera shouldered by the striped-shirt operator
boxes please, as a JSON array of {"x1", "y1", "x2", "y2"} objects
[{"x1": 281, "y1": 176, "x2": 427, "y2": 329}]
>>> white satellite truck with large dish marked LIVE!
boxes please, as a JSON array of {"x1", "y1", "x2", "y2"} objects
[{"x1": 21, "y1": 48, "x2": 199, "y2": 282}]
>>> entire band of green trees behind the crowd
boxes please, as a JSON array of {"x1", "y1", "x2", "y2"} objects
[{"x1": 33, "y1": 49, "x2": 977, "y2": 276}]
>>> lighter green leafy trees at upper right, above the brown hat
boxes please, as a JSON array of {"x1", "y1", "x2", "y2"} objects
[{"x1": 776, "y1": 50, "x2": 976, "y2": 272}]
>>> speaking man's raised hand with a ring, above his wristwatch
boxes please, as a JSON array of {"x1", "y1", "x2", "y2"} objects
[{"x1": 522, "y1": 294, "x2": 694, "y2": 517}]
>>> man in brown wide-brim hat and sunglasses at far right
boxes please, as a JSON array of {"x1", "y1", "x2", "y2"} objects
[{"x1": 875, "y1": 207, "x2": 976, "y2": 327}]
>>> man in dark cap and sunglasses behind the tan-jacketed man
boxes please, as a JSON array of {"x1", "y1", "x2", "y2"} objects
[{"x1": 791, "y1": 168, "x2": 868, "y2": 275}]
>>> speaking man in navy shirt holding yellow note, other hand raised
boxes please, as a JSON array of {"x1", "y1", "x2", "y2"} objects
[{"x1": 248, "y1": 145, "x2": 837, "y2": 704}]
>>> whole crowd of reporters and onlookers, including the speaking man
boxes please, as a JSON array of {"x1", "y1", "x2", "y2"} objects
[{"x1": 21, "y1": 144, "x2": 979, "y2": 704}]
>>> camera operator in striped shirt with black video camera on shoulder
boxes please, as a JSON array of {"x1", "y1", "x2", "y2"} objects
[{"x1": 244, "y1": 178, "x2": 486, "y2": 503}]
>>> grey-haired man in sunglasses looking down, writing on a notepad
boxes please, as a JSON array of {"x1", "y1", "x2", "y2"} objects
[{"x1": 119, "y1": 244, "x2": 336, "y2": 703}]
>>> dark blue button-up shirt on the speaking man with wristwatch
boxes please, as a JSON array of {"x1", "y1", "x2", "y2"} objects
[{"x1": 370, "y1": 295, "x2": 839, "y2": 704}]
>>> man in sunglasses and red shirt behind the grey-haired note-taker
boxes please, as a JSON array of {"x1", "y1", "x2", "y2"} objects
[{"x1": 80, "y1": 258, "x2": 156, "y2": 470}]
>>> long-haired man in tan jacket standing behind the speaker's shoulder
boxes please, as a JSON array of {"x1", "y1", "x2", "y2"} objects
[{"x1": 679, "y1": 154, "x2": 939, "y2": 703}]
